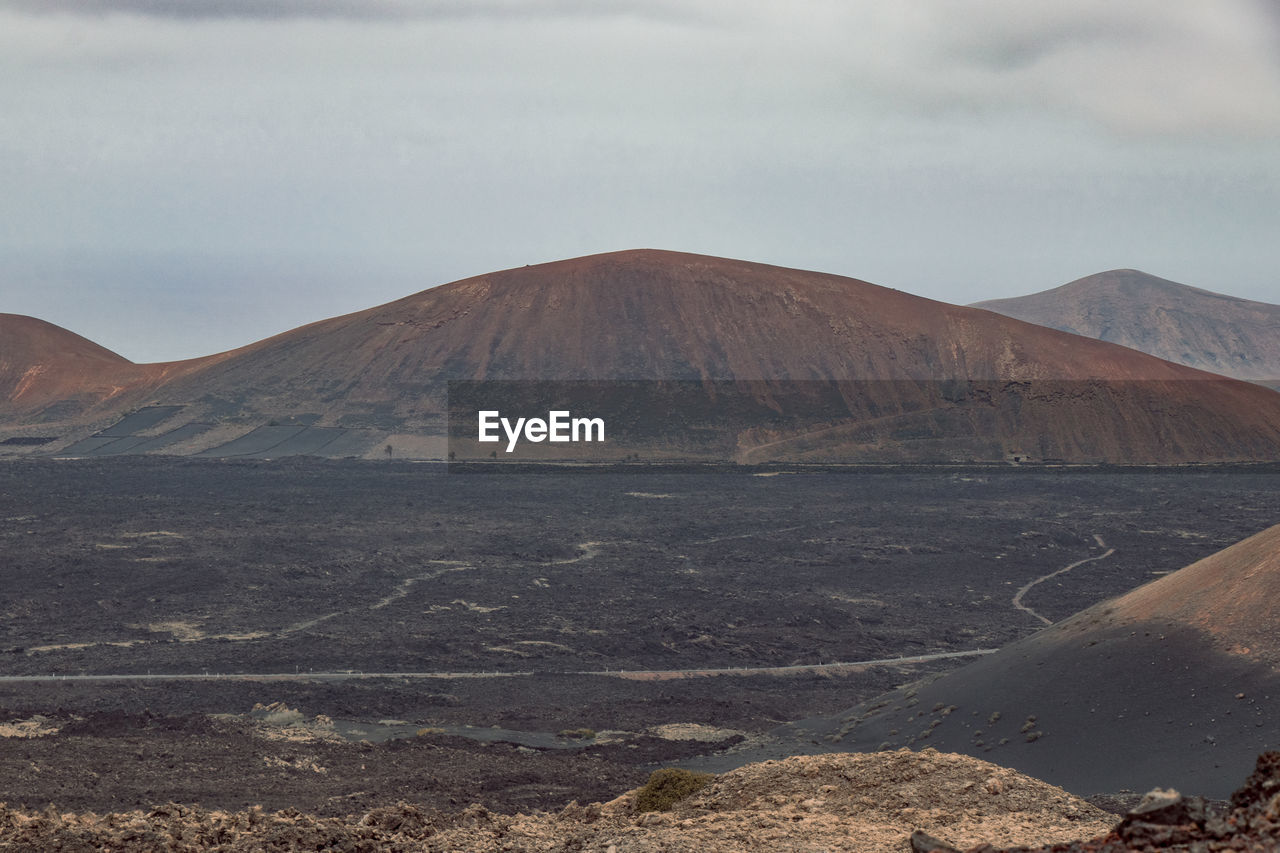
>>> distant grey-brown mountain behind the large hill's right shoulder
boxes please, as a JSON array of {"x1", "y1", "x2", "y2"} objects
[{"x1": 974, "y1": 269, "x2": 1280, "y2": 387}]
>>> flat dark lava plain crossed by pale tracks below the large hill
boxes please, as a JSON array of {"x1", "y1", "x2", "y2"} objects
[{"x1": 0, "y1": 459, "x2": 1280, "y2": 813}]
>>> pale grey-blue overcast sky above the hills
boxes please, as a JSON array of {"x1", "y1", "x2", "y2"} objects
[{"x1": 0, "y1": 0, "x2": 1280, "y2": 361}]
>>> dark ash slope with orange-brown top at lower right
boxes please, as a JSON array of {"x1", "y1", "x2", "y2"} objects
[{"x1": 799, "y1": 525, "x2": 1280, "y2": 798}]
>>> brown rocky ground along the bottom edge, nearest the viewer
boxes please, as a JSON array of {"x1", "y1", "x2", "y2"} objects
[{"x1": 0, "y1": 749, "x2": 1280, "y2": 853}]
